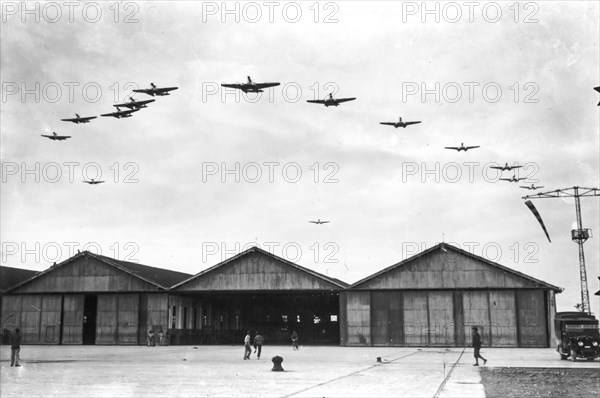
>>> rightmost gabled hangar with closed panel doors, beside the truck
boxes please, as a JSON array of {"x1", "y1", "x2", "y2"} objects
[{"x1": 340, "y1": 244, "x2": 562, "y2": 347}]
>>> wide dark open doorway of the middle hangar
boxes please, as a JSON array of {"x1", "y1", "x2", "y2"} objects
[{"x1": 169, "y1": 291, "x2": 340, "y2": 345}]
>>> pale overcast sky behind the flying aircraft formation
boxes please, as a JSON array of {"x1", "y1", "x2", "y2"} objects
[{"x1": 0, "y1": 1, "x2": 600, "y2": 313}]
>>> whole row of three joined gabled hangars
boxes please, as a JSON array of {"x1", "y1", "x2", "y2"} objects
[{"x1": 1, "y1": 243, "x2": 562, "y2": 347}]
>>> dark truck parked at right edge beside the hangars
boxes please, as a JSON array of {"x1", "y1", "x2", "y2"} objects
[{"x1": 554, "y1": 312, "x2": 600, "y2": 362}]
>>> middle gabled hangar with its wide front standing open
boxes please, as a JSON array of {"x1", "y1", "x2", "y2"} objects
[{"x1": 169, "y1": 247, "x2": 347, "y2": 345}]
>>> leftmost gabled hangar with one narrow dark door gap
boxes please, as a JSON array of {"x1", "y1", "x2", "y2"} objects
[{"x1": 1, "y1": 252, "x2": 190, "y2": 344}]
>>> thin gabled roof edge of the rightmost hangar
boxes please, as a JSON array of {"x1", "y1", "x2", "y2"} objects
[{"x1": 349, "y1": 243, "x2": 564, "y2": 293}]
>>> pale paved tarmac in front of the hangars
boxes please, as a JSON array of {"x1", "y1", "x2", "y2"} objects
[{"x1": 0, "y1": 345, "x2": 600, "y2": 397}]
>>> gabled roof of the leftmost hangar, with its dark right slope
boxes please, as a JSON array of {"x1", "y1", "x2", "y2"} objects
[{"x1": 7, "y1": 251, "x2": 191, "y2": 291}]
